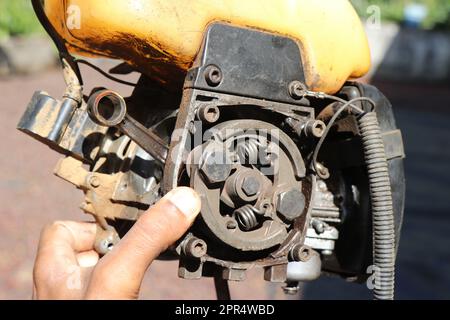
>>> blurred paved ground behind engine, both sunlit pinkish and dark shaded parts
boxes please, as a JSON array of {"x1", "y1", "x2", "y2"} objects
[{"x1": 0, "y1": 65, "x2": 450, "y2": 299}]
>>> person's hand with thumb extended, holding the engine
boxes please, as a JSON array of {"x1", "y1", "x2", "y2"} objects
[{"x1": 33, "y1": 187, "x2": 201, "y2": 299}]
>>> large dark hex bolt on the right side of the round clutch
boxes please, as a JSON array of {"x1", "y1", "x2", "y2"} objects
[{"x1": 277, "y1": 188, "x2": 306, "y2": 221}]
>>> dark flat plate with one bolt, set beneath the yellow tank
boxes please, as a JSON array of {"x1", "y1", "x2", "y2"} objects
[{"x1": 185, "y1": 23, "x2": 305, "y2": 104}]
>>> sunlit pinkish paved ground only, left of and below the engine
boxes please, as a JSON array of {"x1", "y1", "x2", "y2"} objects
[{"x1": 0, "y1": 69, "x2": 302, "y2": 299}]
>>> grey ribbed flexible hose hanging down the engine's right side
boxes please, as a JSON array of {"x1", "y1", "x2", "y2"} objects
[{"x1": 358, "y1": 112, "x2": 395, "y2": 300}]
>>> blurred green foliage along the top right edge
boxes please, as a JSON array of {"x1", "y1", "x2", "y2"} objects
[{"x1": 350, "y1": 0, "x2": 450, "y2": 30}]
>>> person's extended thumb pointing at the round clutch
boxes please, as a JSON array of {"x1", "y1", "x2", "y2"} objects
[{"x1": 86, "y1": 187, "x2": 201, "y2": 299}]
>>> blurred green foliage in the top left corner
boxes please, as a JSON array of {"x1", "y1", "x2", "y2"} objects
[{"x1": 0, "y1": 0, "x2": 42, "y2": 38}]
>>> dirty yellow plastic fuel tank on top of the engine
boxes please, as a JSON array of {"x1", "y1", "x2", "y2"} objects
[{"x1": 45, "y1": 0, "x2": 370, "y2": 93}]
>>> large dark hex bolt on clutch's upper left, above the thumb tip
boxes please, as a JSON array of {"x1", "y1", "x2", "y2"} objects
[{"x1": 200, "y1": 151, "x2": 232, "y2": 183}]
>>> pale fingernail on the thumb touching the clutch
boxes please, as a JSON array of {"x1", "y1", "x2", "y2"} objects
[{"x1": 164, "y1": 187, "x2": 201, "y2": 221}]
